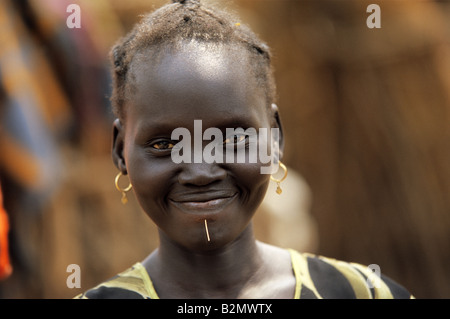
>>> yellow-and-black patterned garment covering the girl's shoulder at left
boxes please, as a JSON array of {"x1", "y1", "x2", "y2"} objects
[{"x1": 75, "y1": 263, "x2": 155, "y2": 299}]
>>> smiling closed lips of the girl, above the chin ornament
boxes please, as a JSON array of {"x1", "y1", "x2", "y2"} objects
[{"x1": 169, "y1": 190, "x2": 237, "y2": 213}]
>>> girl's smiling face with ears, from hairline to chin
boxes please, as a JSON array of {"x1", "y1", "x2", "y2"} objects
[{"x1": 113, "y1": 43, "x2": 279, "y2": 251}]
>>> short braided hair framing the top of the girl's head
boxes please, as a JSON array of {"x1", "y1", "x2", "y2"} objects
[{"x1": 110, "y1": 0, "x2": 275, "y2": 119}]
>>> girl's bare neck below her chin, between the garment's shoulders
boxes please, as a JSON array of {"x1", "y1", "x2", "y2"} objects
[{"x1": 144, "y1": 225, "x2": 263, "y2": 298}]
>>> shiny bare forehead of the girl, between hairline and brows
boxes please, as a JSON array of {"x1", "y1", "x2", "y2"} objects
[{"x1": 127, "y1": 41, "x2": 266, "y2": 127}]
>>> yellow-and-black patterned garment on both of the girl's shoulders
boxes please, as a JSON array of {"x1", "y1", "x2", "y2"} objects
[{"x1": 75, "y1": 250, "x2": 413, "y2": 299}]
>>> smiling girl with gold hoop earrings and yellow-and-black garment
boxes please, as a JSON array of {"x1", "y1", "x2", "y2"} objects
[{"x1": 78, "y1": 0, "x2": 410, "y2": 299}]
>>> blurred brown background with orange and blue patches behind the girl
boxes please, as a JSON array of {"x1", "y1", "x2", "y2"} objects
[{"x1": 0, "y1": 0, "x2": 450, "y2": 298}]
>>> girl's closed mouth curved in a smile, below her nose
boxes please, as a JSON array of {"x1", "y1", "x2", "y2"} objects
[{"x1": 169, "y1": 193, "x2": 236, "y2": 213}]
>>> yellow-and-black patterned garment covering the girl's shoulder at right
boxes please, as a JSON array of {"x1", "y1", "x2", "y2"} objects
[{"x1": 291, "y1": 251, "x2": 413, "y2": 299}]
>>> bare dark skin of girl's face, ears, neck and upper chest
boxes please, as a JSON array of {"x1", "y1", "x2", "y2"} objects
[{"x1": 113, "y1": 42, "x2": 295, "y2": 298}]
